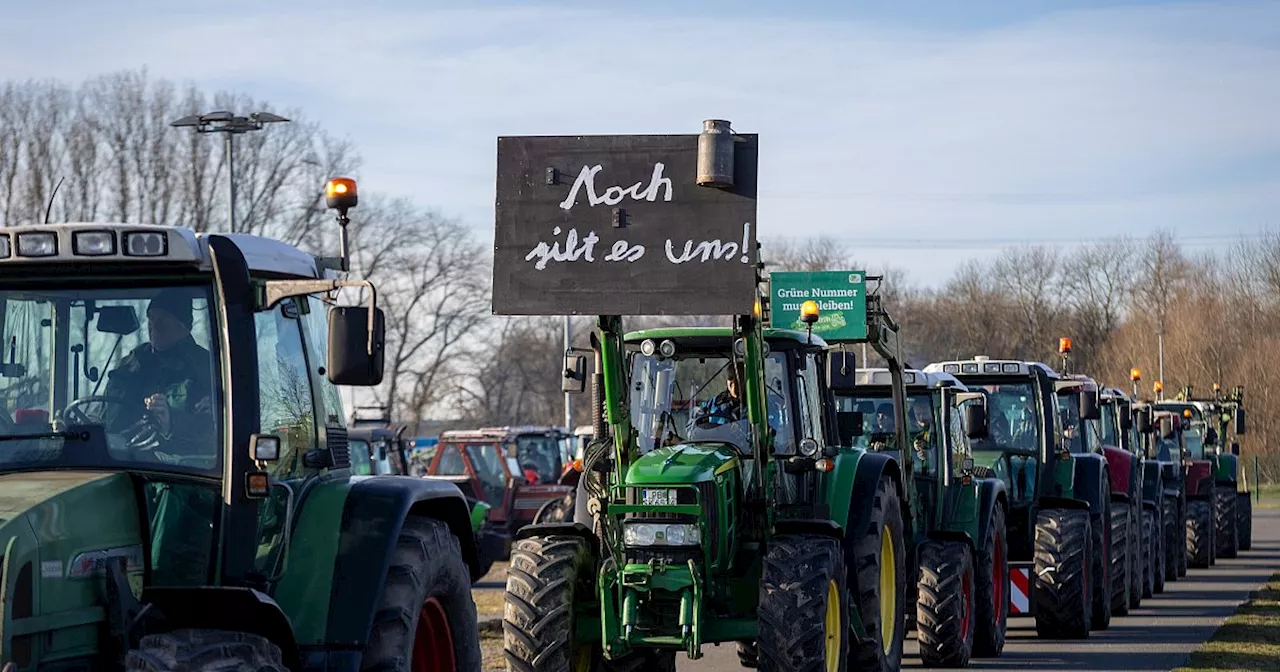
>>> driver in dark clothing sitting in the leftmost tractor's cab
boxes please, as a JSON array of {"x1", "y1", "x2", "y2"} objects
[{"x1": 105, "y1": 287, "x2": 216, "y2": 457}]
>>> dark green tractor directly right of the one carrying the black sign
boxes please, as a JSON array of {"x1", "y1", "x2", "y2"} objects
[{"x1": 831, "y1": 353, "x2": 1009, "y2": 667}]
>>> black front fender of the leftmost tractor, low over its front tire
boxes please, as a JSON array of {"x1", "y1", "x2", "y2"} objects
[{"x1": 142, "y1": 586, "x2": 302, "y2": 669}]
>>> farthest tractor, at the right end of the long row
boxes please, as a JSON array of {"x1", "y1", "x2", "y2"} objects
[{"x1": 1161, "y1": 384, "x2": 1253, "y2": 558}]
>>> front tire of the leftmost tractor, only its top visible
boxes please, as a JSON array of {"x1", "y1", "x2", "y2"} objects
[{"x1": 124, "y1": 630, "x2": 288, "y2": 672}]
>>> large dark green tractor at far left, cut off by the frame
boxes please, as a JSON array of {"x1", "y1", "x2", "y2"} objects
[{"x1": 0, "y1": 178, "x2": 480, "y2": 672}]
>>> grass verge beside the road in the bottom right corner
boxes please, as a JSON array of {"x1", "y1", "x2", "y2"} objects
[{"x1": 1174, "y1": 572, "x2": 1280, "y2": 672}]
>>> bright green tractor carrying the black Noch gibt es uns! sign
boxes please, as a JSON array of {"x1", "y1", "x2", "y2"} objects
[{"x1": 493, "y1": 120, "x2": 909, "y2": 671}]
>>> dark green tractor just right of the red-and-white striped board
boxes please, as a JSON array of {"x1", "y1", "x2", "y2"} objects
[{"x1": 924, "y1": 348, "x2": 1111, "y2": 639}]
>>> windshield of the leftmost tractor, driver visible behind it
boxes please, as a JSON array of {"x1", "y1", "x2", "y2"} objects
[{"x1": 0, "y1": 282, "x2": 221, "y2": 475}]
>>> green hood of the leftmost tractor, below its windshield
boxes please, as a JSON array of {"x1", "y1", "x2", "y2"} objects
[{"x1": 0, "y1": 471, "x2": 143, "y2": 667}]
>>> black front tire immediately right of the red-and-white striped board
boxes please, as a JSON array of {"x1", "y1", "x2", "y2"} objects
[{"x1": 1030, "y1": 508, "x2": 1093, "y2": 639}]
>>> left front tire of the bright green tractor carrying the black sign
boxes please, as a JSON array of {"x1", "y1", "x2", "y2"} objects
[{"x1": 502, "y1": 535, "x2": 599, "y2": 672}]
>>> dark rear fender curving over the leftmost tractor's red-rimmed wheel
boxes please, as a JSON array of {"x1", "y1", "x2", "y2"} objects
[{"x1": 325, "y1": 476, "x2": 479, "y2": 649}]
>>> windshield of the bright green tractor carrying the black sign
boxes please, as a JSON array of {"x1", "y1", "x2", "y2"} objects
[{"x1": 631, "y1": 352, "x2": 795, "y2": 453}]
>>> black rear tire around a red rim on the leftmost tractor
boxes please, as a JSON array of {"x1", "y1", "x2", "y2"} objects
[{"x1": 360, "y1": 516, "x2": 480, "y2": 672}]
